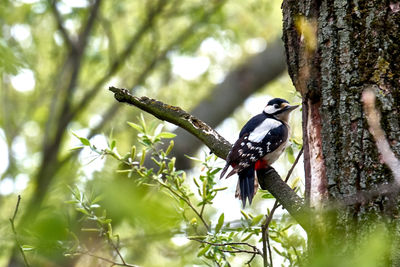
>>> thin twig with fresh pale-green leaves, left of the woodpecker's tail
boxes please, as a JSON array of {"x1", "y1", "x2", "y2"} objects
[{"x1": 73, "y1": 116, "x2": 220, "y2": 231}]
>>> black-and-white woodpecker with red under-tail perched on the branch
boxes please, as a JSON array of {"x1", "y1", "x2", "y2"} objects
[{"x1": 220, "y1": 98, "x2": 298, "y2": 207}]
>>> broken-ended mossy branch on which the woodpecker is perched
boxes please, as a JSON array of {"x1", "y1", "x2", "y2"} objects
[{"x1": 109, "y1": 87, "x2": 309, "y2": 230}]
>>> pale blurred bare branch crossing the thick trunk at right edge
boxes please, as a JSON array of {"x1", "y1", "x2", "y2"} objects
[{"x1": 362, "y1": 89, "x2": 400, "y2": 183}]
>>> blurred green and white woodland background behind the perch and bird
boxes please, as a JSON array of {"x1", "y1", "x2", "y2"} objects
[{"x1": 0, "y1": 0, "x2": 305, "y2": 266}]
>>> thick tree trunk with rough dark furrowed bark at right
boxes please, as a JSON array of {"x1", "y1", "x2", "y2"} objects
[{"x1": 282, "y1": 0, "x2": 400, "y2": 266}]
